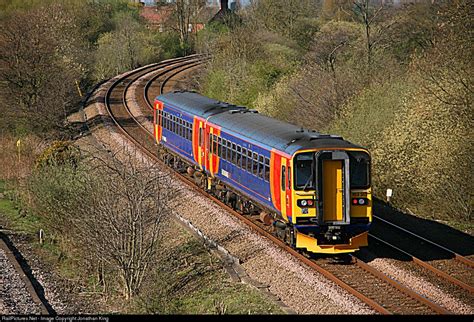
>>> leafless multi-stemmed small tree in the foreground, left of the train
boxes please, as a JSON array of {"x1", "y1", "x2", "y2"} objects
[{"x1": 76, "y1": 147, "x2": 175, "y2": 299}]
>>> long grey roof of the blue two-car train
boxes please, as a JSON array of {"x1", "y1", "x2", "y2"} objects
[{"x1": 157, "y1": 92, "x2": 361, "y2": 155}]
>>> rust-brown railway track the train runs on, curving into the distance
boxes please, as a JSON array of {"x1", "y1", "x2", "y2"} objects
[{"x1": 94, "y1": 56, "x2": 468, "y2": 314}]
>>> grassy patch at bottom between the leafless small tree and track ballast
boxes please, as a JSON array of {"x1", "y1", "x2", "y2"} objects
[{"x1": 134, "y1": 223, "x2": 284, "y2": 314}]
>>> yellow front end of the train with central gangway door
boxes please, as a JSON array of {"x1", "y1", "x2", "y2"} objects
[{"x1": 275, "y1": 147, "x2": 372, "y2": 254}]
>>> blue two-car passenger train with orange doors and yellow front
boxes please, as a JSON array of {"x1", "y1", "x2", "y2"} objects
[{"x1": 153, "y1": 91, "x2": 372, "y2": 254}]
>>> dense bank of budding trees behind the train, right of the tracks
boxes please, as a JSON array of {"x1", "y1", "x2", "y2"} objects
[{"x1": 199, "y1": 0, "x2": 474, "y2": 229}]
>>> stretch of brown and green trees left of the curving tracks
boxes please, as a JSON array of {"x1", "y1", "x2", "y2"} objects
[{"x1": 0, "y1": 0, "x2": 184, "y2": 137}]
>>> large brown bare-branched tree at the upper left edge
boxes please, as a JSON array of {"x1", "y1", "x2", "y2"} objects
[{"x1": 0, "y1": 5, "x2": 84, "y2": 132}]
